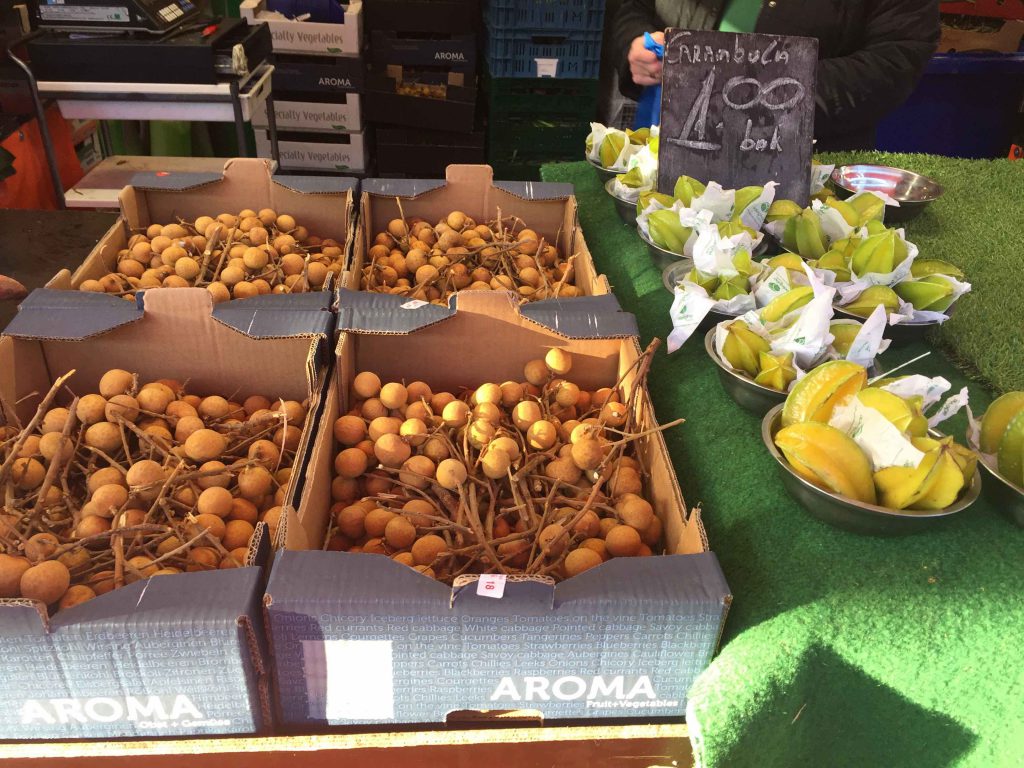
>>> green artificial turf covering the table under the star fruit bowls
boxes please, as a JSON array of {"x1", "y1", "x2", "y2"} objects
[{"x1": 543, "y1": 156, "x2": 1024, "y2": 768}]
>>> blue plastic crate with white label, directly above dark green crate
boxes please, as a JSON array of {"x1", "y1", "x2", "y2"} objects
[{"x1": 487, "y1": 28, "x2": 601, "y2": 78}]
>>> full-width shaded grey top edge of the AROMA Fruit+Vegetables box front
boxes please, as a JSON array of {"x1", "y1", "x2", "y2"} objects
[{"x1": 266, "y1": 550, "x2": 732, "y2": 613}]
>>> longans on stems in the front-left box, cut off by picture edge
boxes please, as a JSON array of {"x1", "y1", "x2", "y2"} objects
[{"x1": 0, "y1": 369, "x2": 306, "y2": 609}]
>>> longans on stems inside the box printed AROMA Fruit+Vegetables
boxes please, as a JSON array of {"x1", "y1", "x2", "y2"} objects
[{"x1": 325, "y1": 342, "x2": 679, "y2": 583}]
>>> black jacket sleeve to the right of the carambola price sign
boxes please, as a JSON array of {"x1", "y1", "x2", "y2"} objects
[{"x1": 814, "y1": 0, "x2": 939, "y2": 143}]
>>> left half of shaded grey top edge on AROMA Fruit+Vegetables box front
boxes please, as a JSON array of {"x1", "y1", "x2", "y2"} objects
[{"x1": 266, "y1": 550, "x2": 452, "y2": 609}]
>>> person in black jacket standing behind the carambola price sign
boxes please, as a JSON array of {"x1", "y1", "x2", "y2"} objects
[{"x1": 613, "y1": 0, "x2": 939, "y2": 151}]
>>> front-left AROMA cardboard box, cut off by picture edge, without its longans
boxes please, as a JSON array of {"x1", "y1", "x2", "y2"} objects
[{"x1": 0, "y1": 289, "x2": 331, "y2": 739}]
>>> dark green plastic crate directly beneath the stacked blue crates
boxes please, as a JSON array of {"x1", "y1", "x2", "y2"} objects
[{"x1": 483, "y1": 76, "x2": 600, "y2": 122}]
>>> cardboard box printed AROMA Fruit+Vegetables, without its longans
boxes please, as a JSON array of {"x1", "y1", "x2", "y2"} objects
[{"x1": 265, "y1": 292, "x2": 731, "y2": 727}]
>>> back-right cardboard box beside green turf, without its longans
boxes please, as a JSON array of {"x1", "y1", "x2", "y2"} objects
[{"x1": 342, "y1": 165, "x2": 611, "y2": 298}]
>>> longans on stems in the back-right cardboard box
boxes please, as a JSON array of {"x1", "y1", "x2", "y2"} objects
[{"x1": 360, "y1": 211, "x2": 580, "y2": 303}]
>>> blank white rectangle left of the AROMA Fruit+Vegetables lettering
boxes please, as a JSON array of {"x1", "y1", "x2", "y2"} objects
[{"x1": 302, "y1": 640, "x2": 394, "y2": 720}]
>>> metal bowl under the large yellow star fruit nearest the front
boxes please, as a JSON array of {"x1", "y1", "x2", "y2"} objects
[{"x1": 761, "y1": 404, "x2": 981, "y2": 536}]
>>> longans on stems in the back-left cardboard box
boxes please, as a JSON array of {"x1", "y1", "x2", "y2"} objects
[{"x1": 79, "y1": 214, "x2": 345, "y2": 302}]
